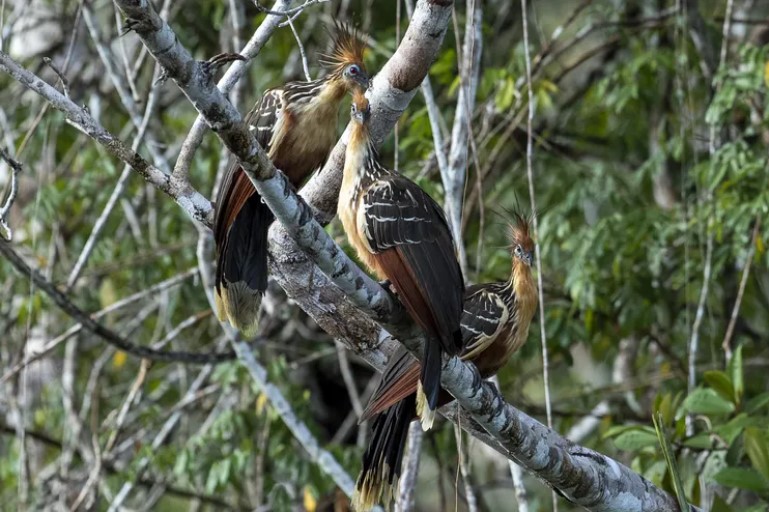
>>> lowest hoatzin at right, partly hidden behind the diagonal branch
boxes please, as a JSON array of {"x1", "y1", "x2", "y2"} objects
[{"x1": 354, "y1": 214, "x2": 537, "y2": 511}]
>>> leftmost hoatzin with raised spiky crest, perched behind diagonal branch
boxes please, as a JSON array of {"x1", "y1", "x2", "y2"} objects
[{"x1": 214, "y1": 24, "x2": 369, "y2": 338}]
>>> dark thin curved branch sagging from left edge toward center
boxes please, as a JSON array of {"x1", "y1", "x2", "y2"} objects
[{"x1": 0, "y1": 240, "x2": 237, "y2": 364}]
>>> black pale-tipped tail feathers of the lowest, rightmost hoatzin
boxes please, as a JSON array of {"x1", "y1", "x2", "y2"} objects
[{"x1": 352, "y1": 394, "x2": 416, "y2": 512}]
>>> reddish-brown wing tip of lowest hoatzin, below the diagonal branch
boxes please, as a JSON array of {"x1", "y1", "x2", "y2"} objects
[{"x1": 360, "y1": 347, "x2": 420, "y2": 421}]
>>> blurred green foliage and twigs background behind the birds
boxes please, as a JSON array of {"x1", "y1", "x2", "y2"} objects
[{"x1": 0, "y1": 0, "x2": 769, "y2": 511}]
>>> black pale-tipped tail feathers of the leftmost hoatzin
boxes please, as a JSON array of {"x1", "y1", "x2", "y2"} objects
[{"x1": 214, "y1": 194, "x2": 273, "y2": 338}]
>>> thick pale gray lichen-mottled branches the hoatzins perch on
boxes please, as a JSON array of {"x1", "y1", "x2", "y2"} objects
[{"x1": 0, "y1": 0, "x2": 696, "y2": 511}]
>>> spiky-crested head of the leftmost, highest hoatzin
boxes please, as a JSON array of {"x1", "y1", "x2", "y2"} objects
[{"x1": 320, "y1": 22, "x2": 369, "y2": 91}]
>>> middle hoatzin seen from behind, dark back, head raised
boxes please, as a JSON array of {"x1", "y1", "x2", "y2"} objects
[{"x1": 338, "y1": 91, "x2": 465, "y2": 428}]
